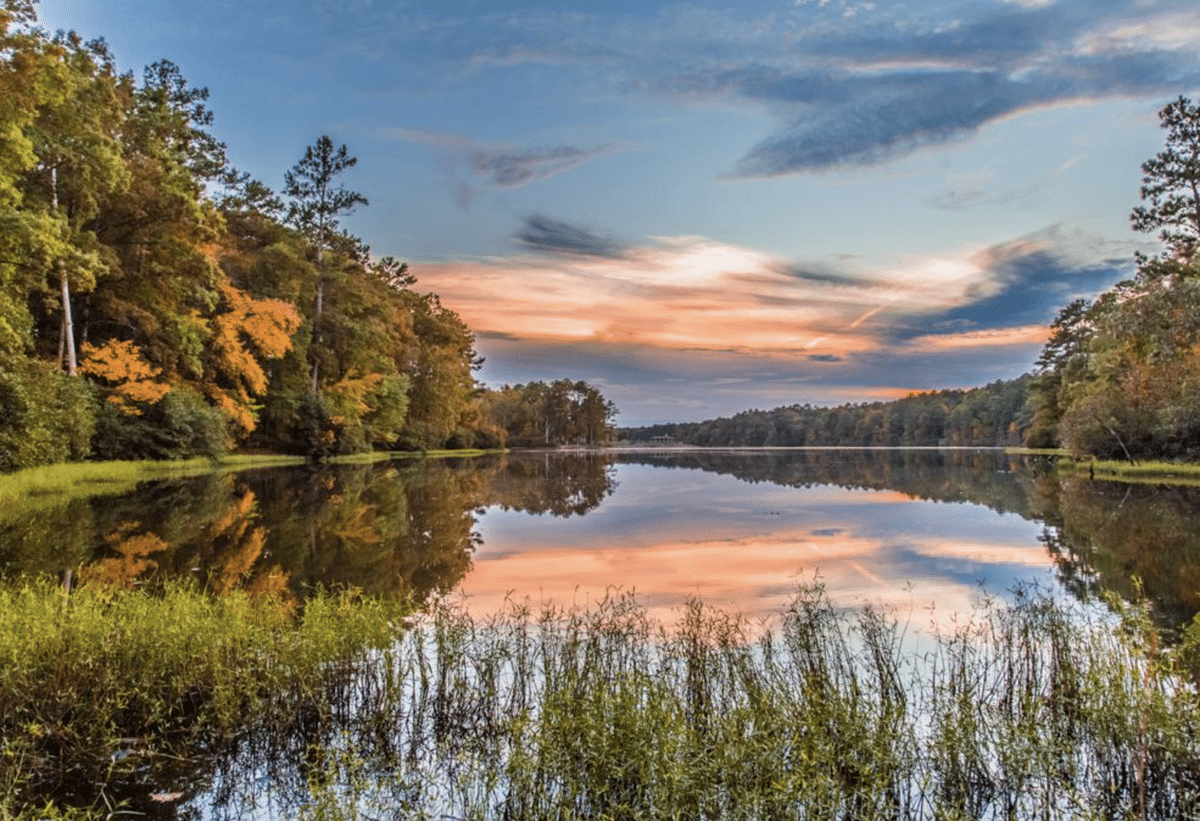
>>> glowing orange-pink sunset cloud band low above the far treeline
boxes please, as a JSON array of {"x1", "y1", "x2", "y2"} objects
[{"x1": 420, "y1": 224, "x2": 1123, "y2": 362}]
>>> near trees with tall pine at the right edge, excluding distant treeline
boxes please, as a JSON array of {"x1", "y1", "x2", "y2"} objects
[{"x1": 1026, "y1": 97, "x2": 1200, "y2": 462}]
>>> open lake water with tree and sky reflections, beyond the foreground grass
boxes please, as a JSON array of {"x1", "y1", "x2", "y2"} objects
[{"x1": 0, "y1": 449, "x2": 1200, "y2": 624}]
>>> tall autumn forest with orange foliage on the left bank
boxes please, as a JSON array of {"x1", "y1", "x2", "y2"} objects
[{"x1": 0, "y1": 0, "x2": 616, "y2": 471}]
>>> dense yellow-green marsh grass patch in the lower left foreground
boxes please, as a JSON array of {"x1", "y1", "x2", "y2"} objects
[{"x1": 0, "y1": 583, "x2": 404, "y2": 817}]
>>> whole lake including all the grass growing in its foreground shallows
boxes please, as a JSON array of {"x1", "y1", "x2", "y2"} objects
[{"x1": 7, "y1": 451, "x2": 1200, "y2": 819}]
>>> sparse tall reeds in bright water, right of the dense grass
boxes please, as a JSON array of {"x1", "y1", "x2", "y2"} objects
[{"x1": 283, "y1": 589, "x2": 1200, "y2": 820}]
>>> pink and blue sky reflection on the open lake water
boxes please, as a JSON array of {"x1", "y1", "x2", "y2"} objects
[{"x1": 460, "y1": 465, "x2": 1056, "y2": 621}]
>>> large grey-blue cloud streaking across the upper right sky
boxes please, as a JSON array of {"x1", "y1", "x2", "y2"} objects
[{"x1": 417, "y1": 0, "x2": 1200, "y2": 178}]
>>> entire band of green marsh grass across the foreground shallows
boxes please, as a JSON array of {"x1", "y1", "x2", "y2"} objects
[{"x1": 9, "y1": 587, "x2": 1200, "y2": 820}]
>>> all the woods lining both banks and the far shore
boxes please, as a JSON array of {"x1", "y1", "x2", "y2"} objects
[{"x1": 0, "y1": 0, "x2": 1200, "y2": 471}]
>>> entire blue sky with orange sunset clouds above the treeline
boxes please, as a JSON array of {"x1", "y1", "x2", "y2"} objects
[{"x1": 38, "y1": 0, "x2": 1200, "y2": 425}]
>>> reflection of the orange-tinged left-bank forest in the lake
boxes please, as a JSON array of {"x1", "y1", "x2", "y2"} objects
[{"x1": 0, "y1": 454, "x2": 614, "y2": 601}]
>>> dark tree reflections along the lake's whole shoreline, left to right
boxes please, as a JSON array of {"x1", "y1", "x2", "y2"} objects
[{"x1": 0, "y1": 449, "x2": 1200, "y2": 625}]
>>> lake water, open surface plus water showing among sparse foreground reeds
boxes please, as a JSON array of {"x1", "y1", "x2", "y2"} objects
[{"x1": 0, "y1": 449, "x2": 1200, "y2": 821}]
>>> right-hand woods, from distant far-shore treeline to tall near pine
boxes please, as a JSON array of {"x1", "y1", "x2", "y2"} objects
[{"x1": 620, "y1": 97, "x2": 1200, "y2": 461}]
